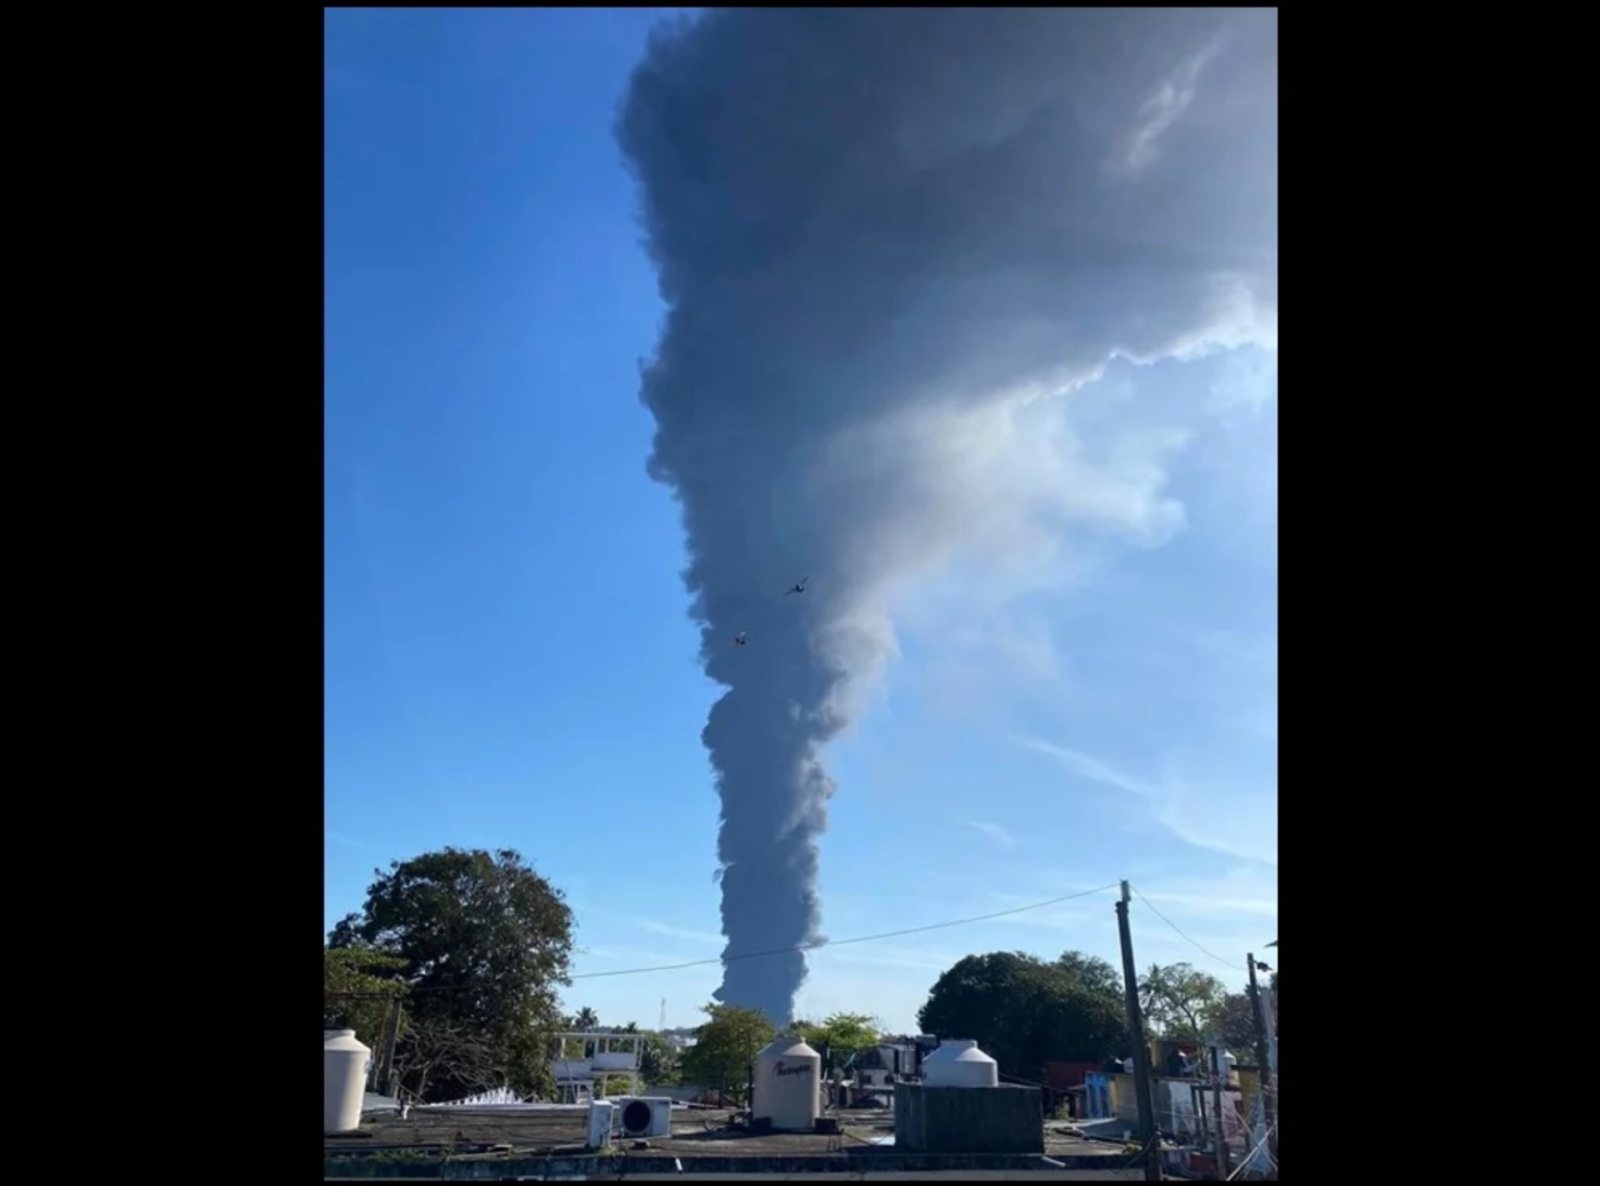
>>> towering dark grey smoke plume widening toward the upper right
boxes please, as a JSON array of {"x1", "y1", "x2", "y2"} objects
[{"x1": 618, "y1": 8, "x2": 1277, "y2": 1023}]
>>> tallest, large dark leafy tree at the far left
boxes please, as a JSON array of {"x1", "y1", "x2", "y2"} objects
[{"x1": 328, "y1": 848, "x2": 573, "y2": 1098}]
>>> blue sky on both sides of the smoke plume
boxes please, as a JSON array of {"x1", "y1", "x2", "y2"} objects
[{"x1": 325, "y1": 10, "x2": 1277, "y2": 1029}]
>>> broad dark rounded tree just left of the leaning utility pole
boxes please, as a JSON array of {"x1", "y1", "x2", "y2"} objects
[{"x1": 917, "y1": 951, "x2": 1126, "y2": 1080}]
